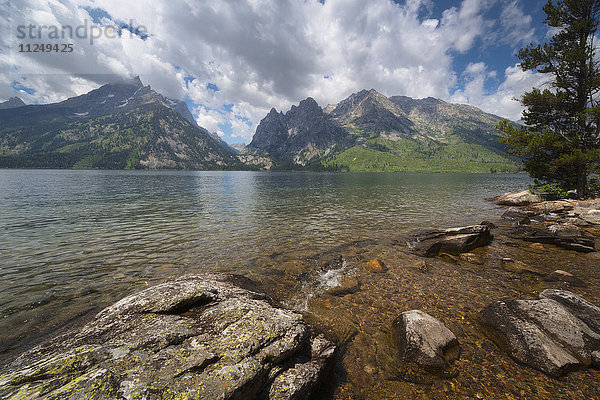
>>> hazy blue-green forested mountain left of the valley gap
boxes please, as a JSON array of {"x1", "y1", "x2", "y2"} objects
[{"x1": 0, "y1": 77, "x2": 241, "y2": 169}]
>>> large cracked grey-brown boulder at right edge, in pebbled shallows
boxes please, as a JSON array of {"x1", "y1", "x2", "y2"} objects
[{"x1": 480, "y1": 290, "x2": 600, "y2": 376}]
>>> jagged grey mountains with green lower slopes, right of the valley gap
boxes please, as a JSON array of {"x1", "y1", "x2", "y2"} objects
[{"x1": 242, "y1": 89, "x2": 519, "y2": 172}]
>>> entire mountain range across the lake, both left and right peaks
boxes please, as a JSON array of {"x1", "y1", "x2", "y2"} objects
[{"x1": 0, "y1": 82, "x2": 519, "y2": 172}]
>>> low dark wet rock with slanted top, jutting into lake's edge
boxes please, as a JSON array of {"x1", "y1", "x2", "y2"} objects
[{"x1": 411, "y1": 225, "x2": 493, "y2": 257}]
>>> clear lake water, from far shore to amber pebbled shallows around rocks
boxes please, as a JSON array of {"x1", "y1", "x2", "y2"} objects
[{"x1": 0, "y1": 170, "x2": 600, "y2": 400}]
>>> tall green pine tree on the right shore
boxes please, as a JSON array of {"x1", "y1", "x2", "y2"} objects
[{"x1": 498, "y1": 0, "x2": 600, "y2": 198}]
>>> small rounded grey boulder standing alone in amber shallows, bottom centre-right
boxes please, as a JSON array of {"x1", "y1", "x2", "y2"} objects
[{"x1": 392, "y1": 310, "x2": 460, "y2": 372}]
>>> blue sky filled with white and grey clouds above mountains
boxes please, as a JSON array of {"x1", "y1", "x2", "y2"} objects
[{"x1": 0, "y1": 0, "x2": 548, "y2": 143}]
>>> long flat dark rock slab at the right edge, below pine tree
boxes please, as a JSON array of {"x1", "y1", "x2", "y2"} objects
[{"x1": 509, "y1": 224, "x2": 596, "y2": 252}]
